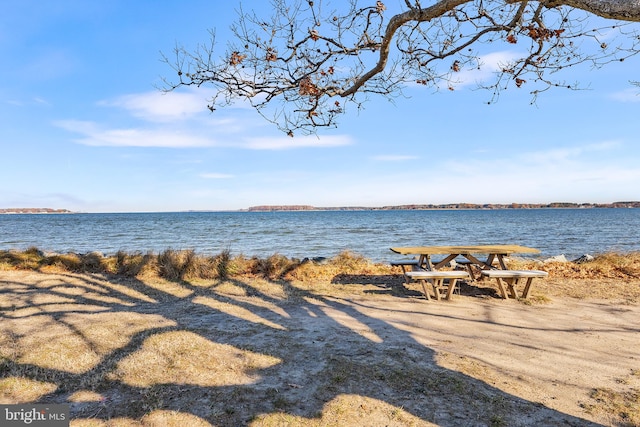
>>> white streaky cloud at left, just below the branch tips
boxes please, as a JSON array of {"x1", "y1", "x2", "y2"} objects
[{"x1": 54, "y1": 89, "x2": 352, "y2": 150}]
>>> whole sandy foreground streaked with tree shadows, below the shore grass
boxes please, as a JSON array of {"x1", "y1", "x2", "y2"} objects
[{"x1": 0, "y1": 256, "x2": 640, "y2": 426}]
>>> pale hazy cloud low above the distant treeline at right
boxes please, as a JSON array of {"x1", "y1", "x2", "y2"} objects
[{"x1": 404, "y1": 141, "x2": 640, "y2": 203}]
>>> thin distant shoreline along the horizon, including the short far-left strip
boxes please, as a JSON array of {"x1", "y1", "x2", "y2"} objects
[{"x1": 0, "y1": 201, "x2": 640, "y2": 215}]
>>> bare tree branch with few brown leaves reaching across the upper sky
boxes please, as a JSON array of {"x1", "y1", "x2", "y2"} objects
[{"x1": 163, "y1": 0, "x2": 640, "y2": 135}]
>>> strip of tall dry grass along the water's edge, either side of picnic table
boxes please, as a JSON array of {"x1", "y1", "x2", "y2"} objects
[{"x1": 0, "y1": 248, "x2": 640, "y2": 288}]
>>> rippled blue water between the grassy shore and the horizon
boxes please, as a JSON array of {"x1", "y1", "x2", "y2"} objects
[{"x1": 0, "y1": 209, "x2": 640, "y2": 262}]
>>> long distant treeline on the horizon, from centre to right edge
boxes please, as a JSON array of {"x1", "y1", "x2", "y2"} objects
[{"x1": 246, "y1": 201, "x2": 640, "y2": 212}]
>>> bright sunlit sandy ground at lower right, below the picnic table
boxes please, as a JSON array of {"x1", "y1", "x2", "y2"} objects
[{"x1": 340, "y1": 299, "x2": 640, "y2": 425}]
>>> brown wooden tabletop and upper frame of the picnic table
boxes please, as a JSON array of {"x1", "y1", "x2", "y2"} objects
[{"x1": 391, "y1": 245, "x2": 540, "y2": 270}]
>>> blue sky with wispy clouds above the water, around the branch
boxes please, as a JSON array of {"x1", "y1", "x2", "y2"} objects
[{"x1": 0, "y1": 0, "x2": 640, "y2": 212}]
